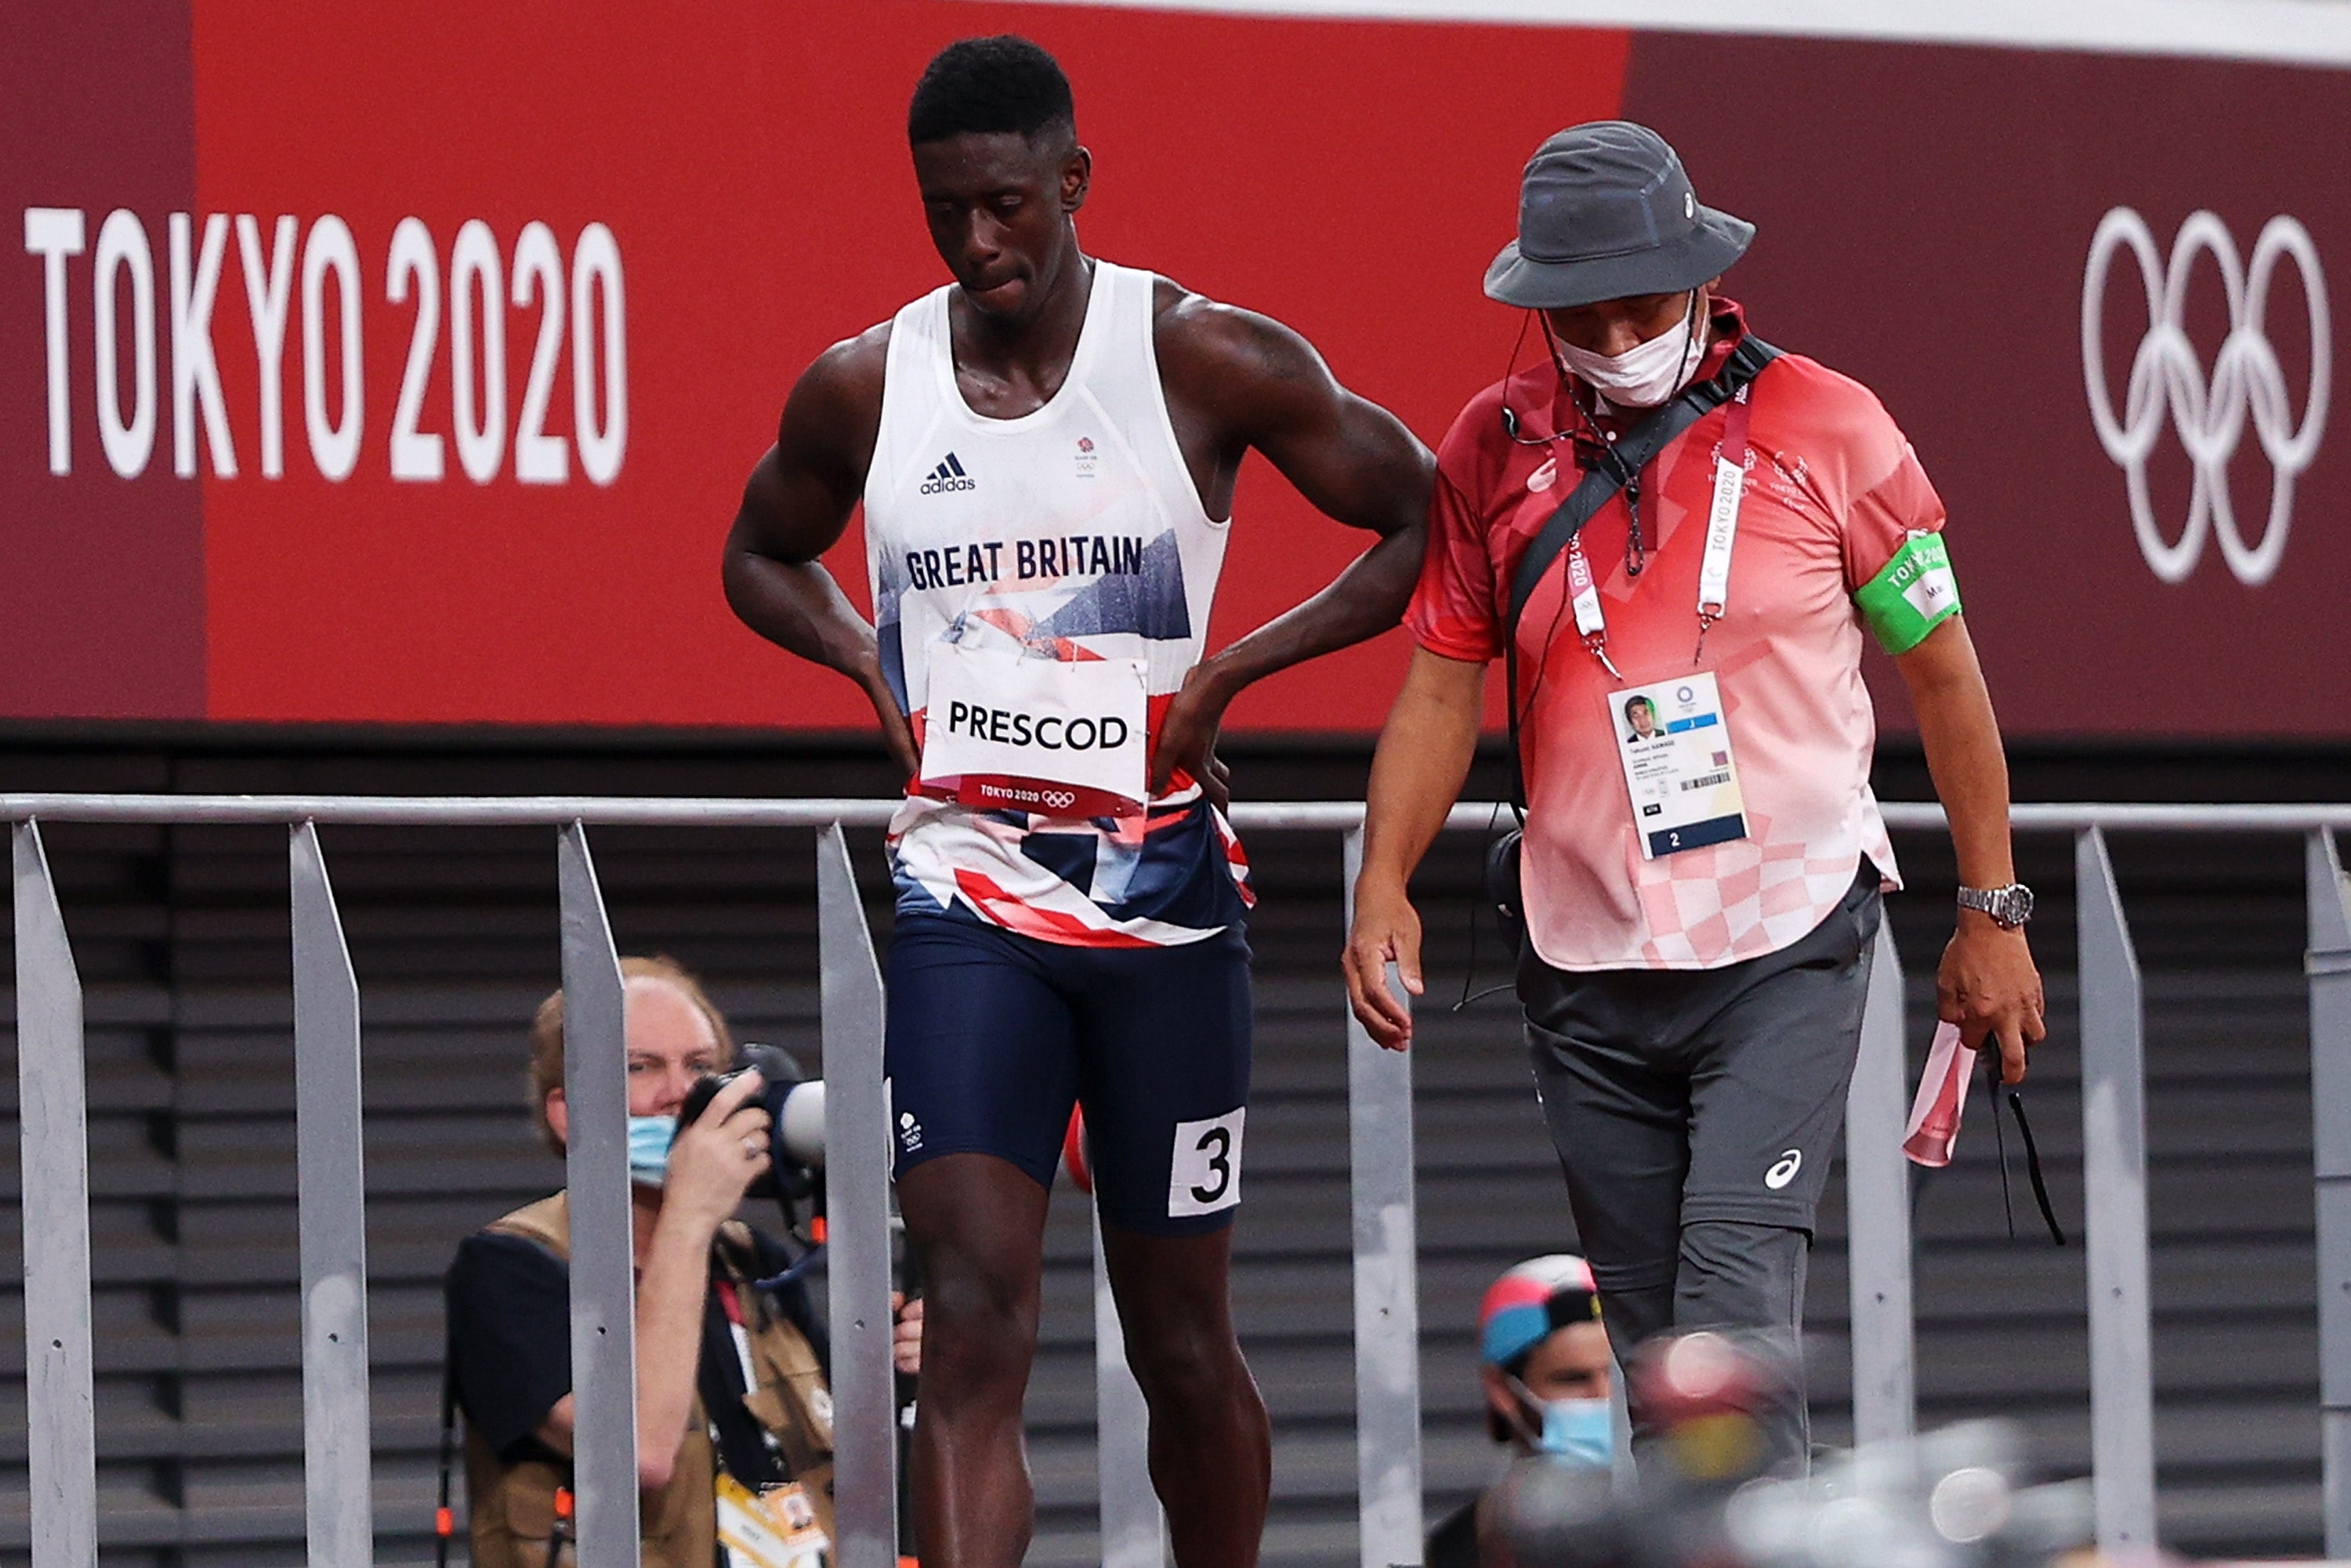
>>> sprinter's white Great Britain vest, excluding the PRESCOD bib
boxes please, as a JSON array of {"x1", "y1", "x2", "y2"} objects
[{"x1": 865, "y1": 261, "x2": 1244, "y2": 945}]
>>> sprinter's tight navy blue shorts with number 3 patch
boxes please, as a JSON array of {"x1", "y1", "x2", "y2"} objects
[{"x1": 884, "y1": 914, "x2": 1251, "y2": 1237}]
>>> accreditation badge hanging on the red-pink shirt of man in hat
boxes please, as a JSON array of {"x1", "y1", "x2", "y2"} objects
[{"x1": 1608, "y1": 670, "x2": 1747, "y2": 860}]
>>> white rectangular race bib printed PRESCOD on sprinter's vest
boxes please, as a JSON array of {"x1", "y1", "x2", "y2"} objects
[{"x1": 922, "y1": 642, "x2": 1150, "y2": 816}]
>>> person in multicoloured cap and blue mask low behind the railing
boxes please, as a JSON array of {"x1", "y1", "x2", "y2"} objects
[{"x1": 1425, "y1": 1253, "x2": 1615, "y2": 1568}]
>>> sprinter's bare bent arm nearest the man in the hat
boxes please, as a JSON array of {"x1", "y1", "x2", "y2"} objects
[{"x1": 1152, "y1": 280, "x2": 1436, "y2": 790}]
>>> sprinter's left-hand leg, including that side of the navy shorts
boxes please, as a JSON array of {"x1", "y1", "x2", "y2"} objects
[{"x1": 886, "y1": 917, "x2": 1077, "y2": 1568}]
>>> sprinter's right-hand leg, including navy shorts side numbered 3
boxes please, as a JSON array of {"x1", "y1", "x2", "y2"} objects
[{"x1": 1060, "y1": 926, "x2": 1272, "y2": 1568}]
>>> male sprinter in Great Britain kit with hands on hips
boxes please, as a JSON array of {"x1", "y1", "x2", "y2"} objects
[{"x1": 726, "y1": 38, "x2": 1432, "y2": 1568}]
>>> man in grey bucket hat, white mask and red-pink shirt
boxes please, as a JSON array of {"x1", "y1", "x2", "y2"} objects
[{"x1": 1345, "y1": 120, "x2": 2043, "y2": 1467}]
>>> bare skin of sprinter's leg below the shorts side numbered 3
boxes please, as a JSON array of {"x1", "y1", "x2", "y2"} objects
[{"x1": 1103, "y1": 1222, "x2": 1274, "y2": 1568}]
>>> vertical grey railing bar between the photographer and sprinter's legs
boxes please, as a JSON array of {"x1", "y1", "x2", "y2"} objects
[{"x1": 816, "y1": 823, "x2": 898, "y2": 1568}]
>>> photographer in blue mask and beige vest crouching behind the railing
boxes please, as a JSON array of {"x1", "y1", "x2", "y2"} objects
[{"x1": 447, "y1": 959, "x2": 922, "y2": 1568}]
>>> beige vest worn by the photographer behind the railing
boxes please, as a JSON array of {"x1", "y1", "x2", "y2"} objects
[{"x1": 465, "y1": 1192, "x2": 832, "y2": 1568}]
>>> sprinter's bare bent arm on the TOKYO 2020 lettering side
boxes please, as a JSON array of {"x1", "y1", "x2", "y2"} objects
[{"x1": 724, "y1": 324, "x2": 922, "y2": 776}]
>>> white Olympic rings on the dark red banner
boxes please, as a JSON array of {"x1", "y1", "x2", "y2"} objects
[{"x1": 2081, "y1": 207, "x2": 2332, "y2": 588}]
